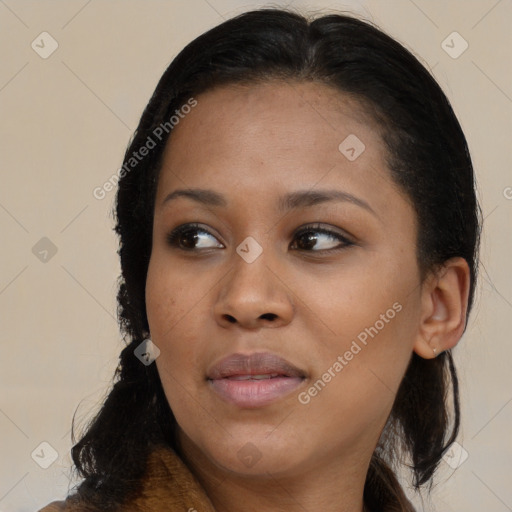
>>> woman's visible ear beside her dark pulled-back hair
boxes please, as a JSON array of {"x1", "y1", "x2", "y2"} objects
[{"x1": 413, "y1": 257, "x2": 470, "y2": 359}]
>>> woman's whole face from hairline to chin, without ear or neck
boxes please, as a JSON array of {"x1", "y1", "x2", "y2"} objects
[{"x1": 146, "y1": 82, "x2": 421, "y2": 475}]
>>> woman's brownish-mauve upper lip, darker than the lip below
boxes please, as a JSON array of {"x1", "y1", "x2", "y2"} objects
[{"x1": 207, "y1": 352, "x2": 305, "y2": 380}]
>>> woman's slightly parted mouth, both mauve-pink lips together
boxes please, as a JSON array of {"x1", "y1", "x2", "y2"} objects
[{"x1": 207, "y1": 353, "x2": 306, "y2": 409}]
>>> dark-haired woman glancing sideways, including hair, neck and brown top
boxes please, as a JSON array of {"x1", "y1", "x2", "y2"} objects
[{"x1": 43, "y1": 9, "x2": 480, "y2": 512}]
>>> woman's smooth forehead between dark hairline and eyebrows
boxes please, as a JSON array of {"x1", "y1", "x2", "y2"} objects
[{"x1": 157, "y1": 81, "x2": 408, "y2": 216}]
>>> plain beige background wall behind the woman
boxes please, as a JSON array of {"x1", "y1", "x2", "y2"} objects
[{"x1": 0, "y1": 0, "x2": 512, "y2": 512}]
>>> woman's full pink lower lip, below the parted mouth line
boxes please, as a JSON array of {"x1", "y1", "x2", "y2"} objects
[{"x1": 209, "y1": 377, "x2": 304, "y2": 408}]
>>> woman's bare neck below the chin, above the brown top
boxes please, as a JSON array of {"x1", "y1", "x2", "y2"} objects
[{"x1": 179, "y1": 433, "x2": 371, "y2": 512}]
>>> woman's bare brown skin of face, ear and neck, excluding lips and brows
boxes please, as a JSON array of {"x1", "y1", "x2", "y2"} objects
[{"x1": 146, "y1": 82, "x2": 469, "y2": 512}]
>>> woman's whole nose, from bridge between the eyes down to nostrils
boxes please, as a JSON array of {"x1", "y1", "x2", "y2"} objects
[{"x1": 214, "y1": 237, "x2": 293, "y2": 327}]
